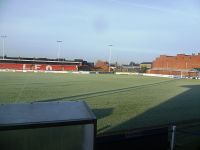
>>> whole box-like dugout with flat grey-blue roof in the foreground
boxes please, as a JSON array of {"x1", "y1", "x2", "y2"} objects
[{"x1": 0, "y1": 102, "x2": 96, "y2": 150}]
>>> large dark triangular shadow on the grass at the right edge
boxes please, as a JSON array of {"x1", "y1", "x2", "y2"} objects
[{"x1": 106, "y1": 85, "x2": 200, "y2": 132}]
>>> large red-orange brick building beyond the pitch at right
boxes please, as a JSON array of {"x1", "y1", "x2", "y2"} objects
[{"x1": 148, "y1": 53, "x2": 200, "y2": 77}]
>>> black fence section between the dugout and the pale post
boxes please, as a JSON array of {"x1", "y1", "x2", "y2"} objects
[{"x1": 96, "y1": 127, "x2": 169, "y2": 150}]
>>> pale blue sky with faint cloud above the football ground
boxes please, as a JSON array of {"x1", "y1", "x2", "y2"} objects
[{"x1": 0, "y1": 0, "x2": 200, "y2": 63}]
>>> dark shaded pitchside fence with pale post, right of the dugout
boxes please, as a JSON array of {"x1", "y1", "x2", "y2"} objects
[{"x1": 96, "y1": 120, "x2": 200, "y2": 150}]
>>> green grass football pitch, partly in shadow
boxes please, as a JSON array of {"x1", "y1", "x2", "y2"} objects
[{"x1": 0, "y1": 72, "x2": 200, "y2": 134}]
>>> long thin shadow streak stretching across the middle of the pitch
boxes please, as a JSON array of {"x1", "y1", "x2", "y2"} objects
[{"x1": 36, "y1": 80, "x2": 174, "y2": 102}]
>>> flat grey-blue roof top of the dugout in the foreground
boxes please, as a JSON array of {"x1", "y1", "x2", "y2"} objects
[{"x1": 0, "y1": 101, "x2": 96, "y2": 130}]
